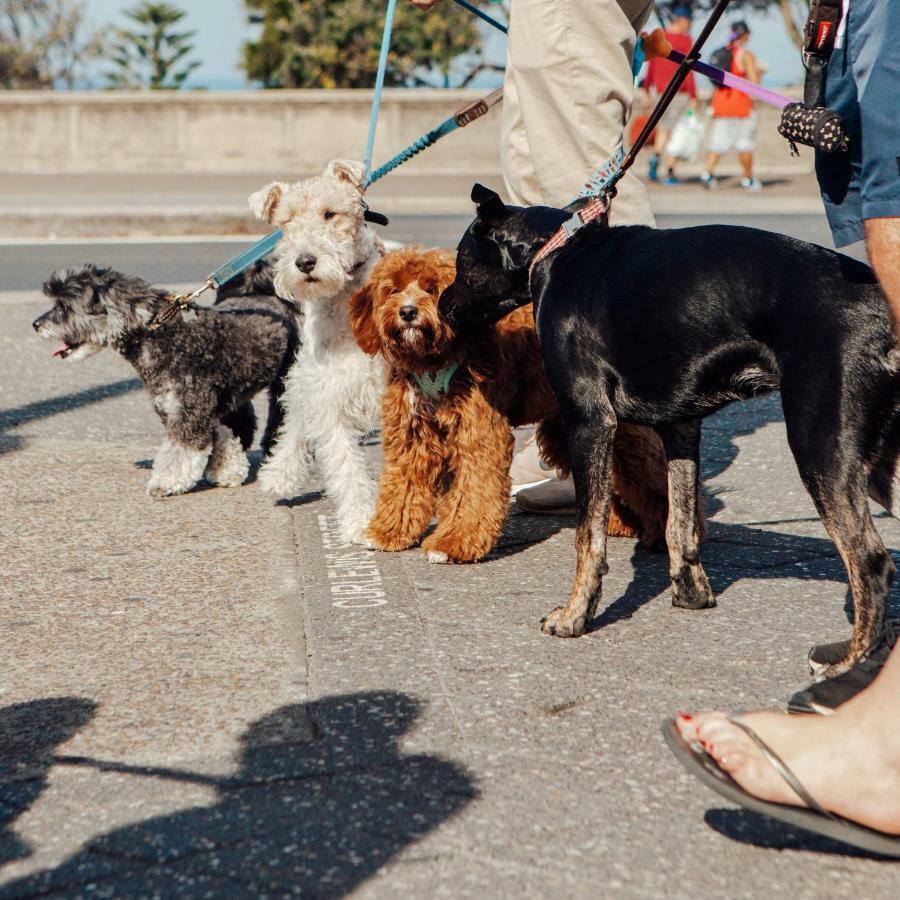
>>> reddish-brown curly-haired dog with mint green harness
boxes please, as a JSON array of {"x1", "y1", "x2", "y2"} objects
[{"x1": 350, "y1": 243, "x2": 667, "y2": 562}]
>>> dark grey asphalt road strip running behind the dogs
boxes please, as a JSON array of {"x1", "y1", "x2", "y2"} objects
[{"x1": 0, "y1": 215, "x2": 859, "y2": 291}]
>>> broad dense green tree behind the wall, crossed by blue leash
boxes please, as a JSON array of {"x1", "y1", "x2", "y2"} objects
[{"x1": 244, "y1": 0, "x2": 496, "y2": 88}]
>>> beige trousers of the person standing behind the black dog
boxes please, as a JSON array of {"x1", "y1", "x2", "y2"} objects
[{"x1": 501, "y1": 0, "x2": 654, "y2": 225}]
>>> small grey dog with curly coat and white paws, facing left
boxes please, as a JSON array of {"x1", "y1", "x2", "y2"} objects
[{"x1": 34, "y1": 263, "x2": 299, "y2": 497}]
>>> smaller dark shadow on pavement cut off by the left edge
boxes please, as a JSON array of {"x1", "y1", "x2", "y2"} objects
[{"x1": 0, "y1": 697, "x2": 97, "y2": 866}]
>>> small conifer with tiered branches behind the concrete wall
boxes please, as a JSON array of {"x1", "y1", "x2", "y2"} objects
[{"x1": 106, "y1": 2, "x2": 200, "y2": 90}]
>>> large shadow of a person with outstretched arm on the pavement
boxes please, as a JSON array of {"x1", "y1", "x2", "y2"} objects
[{"x1": 0, "y1": 692, "x2": 477, "y2": 897}]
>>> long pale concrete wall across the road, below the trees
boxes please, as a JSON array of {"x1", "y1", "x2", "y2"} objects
[{"x1": 0, "y1": 89, "x2": 811, "y2": 177}]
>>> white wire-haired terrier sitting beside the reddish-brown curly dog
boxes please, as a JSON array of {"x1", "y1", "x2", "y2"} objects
[{"x1": 250, "y1": 160, "x2": 386, "y2": 543}]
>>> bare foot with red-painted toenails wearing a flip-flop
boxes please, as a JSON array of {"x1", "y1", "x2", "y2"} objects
[{"x1": 677, "y1": 651, "x2": 900, "y2": 834}]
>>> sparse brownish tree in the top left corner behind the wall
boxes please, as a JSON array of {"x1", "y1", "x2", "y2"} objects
[{"x1": 0, "y1": 0, "x2": 101, "y2": 89}]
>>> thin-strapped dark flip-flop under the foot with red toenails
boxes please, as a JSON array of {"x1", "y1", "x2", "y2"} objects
[{"x1": 662, "y1": 718, "x2": 900, "y2": 858}]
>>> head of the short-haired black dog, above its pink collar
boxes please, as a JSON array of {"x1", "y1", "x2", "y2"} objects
[{"x1": 439, "y1": 184, "x2": 567, "y2": 330}]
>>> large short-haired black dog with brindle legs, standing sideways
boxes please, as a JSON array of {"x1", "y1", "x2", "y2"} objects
[{"x1": 440, "y1": 185, "x2": 900, "y2": 675}]
